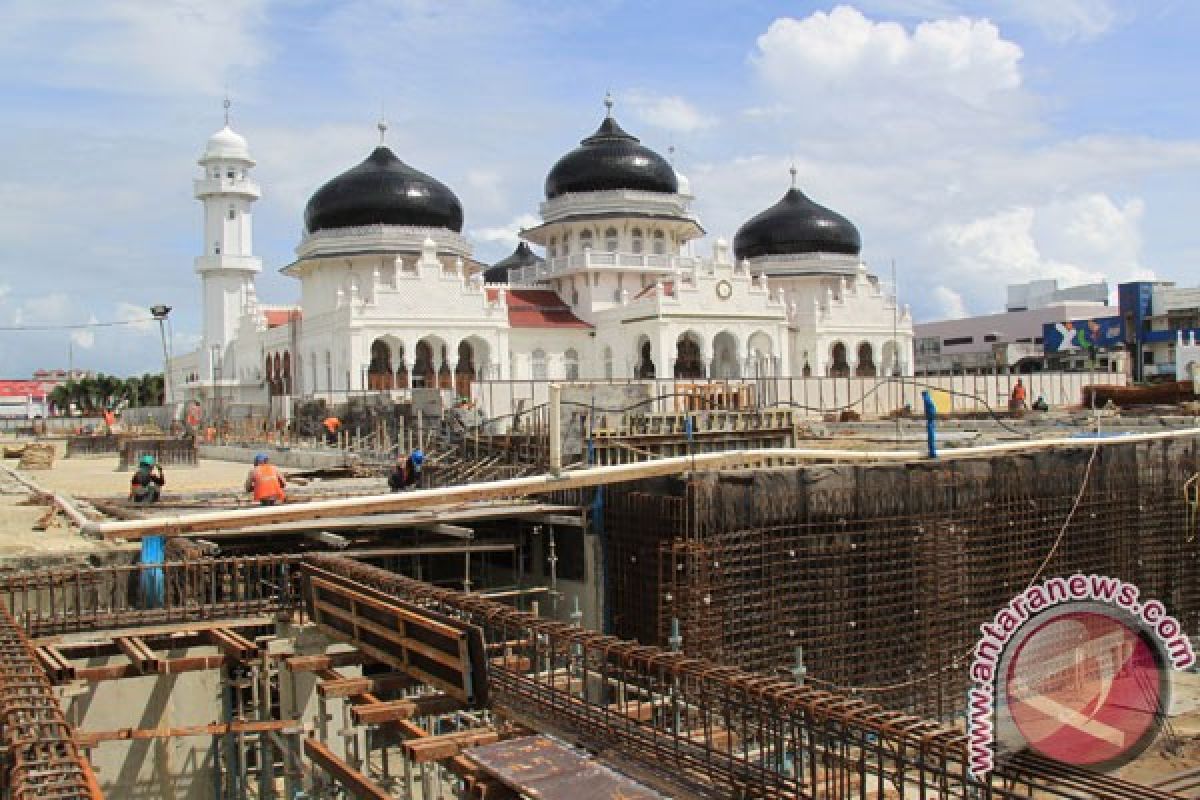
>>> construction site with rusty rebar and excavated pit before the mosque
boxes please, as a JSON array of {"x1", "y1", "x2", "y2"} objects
[{"x1": 0, "y1": 379, "x2": 1200, "y2": 800}]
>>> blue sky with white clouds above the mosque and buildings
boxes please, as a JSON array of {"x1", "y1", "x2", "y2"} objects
[{"x1": 0, "y1": 0, "x2": 1200, "y2": 378}]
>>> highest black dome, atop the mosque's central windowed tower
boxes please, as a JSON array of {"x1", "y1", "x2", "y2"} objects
[{"x1": 546, "y1": 116, "x2": 679, "y2": 200}]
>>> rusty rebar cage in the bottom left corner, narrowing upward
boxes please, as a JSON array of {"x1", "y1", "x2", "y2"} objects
[{"x1": 0, "y1": 606, "x2": 103, "y2": 800}]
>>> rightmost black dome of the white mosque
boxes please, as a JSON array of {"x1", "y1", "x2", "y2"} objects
[{"x1": 733, "y1": 188, "x2": 863, "y2": 261}]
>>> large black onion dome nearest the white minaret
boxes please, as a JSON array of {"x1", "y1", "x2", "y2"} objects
[{"x1": 304, "y1": 145, "x2": 462, "y2": 233}]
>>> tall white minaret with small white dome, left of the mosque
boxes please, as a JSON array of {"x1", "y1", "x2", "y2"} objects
[{"x1": 196, "y1": 98, "x2": 263, "y2": 380}]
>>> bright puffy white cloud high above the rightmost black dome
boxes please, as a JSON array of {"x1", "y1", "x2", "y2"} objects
[{"x1": 751, "y1": 6, "x2": 1022, "y2": 107}]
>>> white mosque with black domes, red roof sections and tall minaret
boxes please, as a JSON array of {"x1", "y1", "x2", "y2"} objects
[{"x1": 170, "y1": 98, "x2": 913, "y2": 404}]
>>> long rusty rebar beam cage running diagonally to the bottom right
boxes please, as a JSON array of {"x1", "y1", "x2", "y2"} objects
[{"x1": 305, "y1": 555, "x2": 1174, "y2": 800}]
